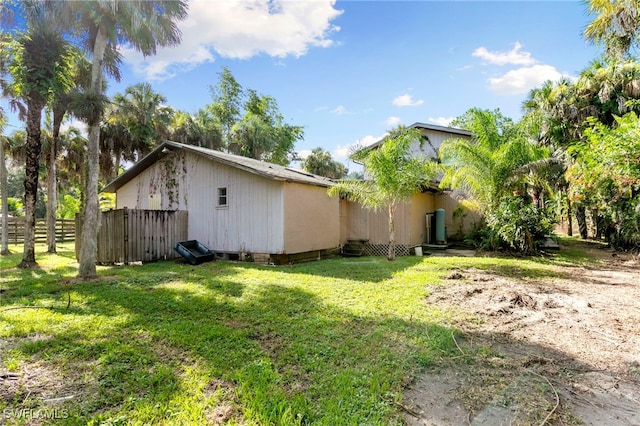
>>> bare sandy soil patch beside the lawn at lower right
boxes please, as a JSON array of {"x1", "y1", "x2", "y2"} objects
[{"x1": 402, "y1": 242, "x2": 640, "y2": 426}]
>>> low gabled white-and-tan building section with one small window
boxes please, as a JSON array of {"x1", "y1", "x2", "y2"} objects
[{"x1": 103, "y1": 142, "x2": 341, "y2": 262}]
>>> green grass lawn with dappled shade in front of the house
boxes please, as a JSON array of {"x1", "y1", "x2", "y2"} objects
[{"x1": 0, "y1": 244, "x2": 588, "y2": 425}]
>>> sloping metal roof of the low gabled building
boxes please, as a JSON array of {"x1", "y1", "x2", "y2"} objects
[{"x1": 102, "y1": 141, "x2": 334, "y2": 192}]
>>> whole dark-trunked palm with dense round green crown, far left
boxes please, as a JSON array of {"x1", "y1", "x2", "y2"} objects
[{"x1": 2, "y1": 19, "x2": 71, "y2": 268}]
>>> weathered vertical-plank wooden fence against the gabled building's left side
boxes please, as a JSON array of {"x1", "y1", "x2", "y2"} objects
[{"x1": 76, "y1": 208, "x2": 188, "y2": 264}]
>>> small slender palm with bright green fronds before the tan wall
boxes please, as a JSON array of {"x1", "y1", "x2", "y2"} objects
[{"x1": 328, "y1": 128, "x2": 437, "y2": 260}]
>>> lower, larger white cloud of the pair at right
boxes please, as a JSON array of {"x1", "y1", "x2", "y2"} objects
[{"x1": 489, "y1": 65, "x2": 569, "y2": 95}]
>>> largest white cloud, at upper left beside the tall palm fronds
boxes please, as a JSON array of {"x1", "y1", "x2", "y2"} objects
[{"x1": 122, "y1": 0, "x2": 342, "y2": 80}]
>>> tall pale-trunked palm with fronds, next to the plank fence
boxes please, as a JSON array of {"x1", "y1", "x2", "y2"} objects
[{"x1": 51, "y1": 0, "x2": 187, "y2": 278}]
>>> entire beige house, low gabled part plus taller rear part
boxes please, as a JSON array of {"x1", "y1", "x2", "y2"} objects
[{"x1": 103, "y1": 123, "x2": 475, "y2": 263}]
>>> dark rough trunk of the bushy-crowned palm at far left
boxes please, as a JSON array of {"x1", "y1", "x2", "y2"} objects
[{"x1": 18, "y1": 105, "x2": 42, "y2": 268}]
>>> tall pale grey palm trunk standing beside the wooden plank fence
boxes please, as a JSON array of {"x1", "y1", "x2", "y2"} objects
[{"x1": 78, "y1": 26, "x2": 107, "y2": 278}]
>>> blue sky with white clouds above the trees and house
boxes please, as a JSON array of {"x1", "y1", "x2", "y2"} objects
[{"x1": 3, "y1": 0, "x2": 601, "y2": 171}]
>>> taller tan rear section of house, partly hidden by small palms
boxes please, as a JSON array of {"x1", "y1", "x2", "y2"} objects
[{"x1": 340, "y1": 123, "x2": 478, "y2": 255}]
